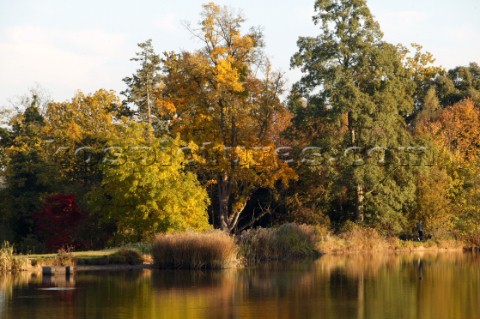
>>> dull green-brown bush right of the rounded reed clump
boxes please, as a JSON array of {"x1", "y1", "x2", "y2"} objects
[{"x1": 238, "y1": 223, "x2": 319, "y2": 262}]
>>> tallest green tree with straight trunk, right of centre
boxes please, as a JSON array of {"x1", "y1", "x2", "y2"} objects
[{"x1": 290, "y1": 0, "x2": 415, "y2": 231}]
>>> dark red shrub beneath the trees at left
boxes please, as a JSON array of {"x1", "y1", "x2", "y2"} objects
[{"x1": 33, "y1": 194, "x2": 86, "y2": 252}]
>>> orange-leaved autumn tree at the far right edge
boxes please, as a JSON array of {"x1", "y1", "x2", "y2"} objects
[{"x1": 416, "y1": 100, "x2": 480, "y2": 237}]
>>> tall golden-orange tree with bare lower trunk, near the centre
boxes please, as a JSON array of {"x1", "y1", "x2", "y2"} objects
[{"x1": 161, "y1": 3, "x2": 294, "y2": 231}]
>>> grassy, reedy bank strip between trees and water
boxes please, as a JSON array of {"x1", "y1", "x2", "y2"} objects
[{"x1": 14, "y1": 223, "x2": 468, "y2": 271}]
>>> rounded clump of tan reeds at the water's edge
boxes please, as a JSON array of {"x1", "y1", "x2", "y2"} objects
[{"x1": 152, "y1": 230, "x2": 237, "y2": 269}]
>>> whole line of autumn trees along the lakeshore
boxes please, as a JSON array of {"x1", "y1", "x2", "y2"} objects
[{"x1": 0, "y1": 0, "x2": 480, "y2": 251}]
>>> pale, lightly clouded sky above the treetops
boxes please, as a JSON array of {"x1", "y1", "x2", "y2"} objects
[{"x1": 0, "y1": 0, "x2": 480, "y2": 109}]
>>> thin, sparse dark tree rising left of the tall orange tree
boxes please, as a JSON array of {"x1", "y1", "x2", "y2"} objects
[{"x1": 122, "y1": 39, "x2": 161, "y2": 129}]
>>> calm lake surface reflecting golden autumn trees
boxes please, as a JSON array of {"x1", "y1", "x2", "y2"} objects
[{"x1": 0, "y1": 253, "x2": 480, "y2": 319}]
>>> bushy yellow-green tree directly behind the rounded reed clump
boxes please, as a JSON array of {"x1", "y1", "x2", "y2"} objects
[{"x1": 87, "y1": 121, "x2": 209, "y2": 242}]
